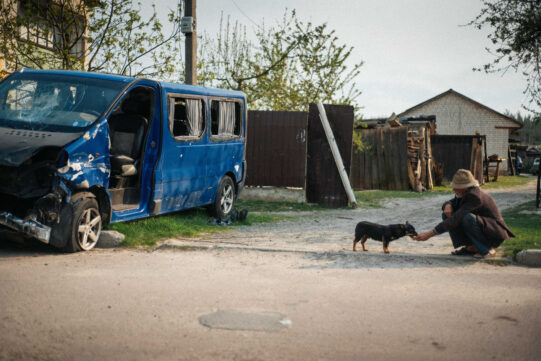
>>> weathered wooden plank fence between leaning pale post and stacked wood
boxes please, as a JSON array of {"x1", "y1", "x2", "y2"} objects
[{"x1": 350, "y1": 127, "x2": 409, "y2": 190}]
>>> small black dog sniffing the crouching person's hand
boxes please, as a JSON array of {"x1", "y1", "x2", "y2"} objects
[{"x1": 353, "y1": 222, "x2": 417, "y2": 253}]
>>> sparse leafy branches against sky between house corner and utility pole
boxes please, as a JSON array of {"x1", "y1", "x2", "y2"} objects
[{"x1": 87, "y1": 0, "x2": 181, "y2": 79}]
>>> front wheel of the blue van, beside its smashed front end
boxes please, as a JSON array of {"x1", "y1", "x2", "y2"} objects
[{"x1": 65, "y1": 198, "x2": 101, "y2": 253}]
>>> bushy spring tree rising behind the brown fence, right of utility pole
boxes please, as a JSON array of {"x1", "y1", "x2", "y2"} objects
[{"x1": 200, "y1": 11, "x2": 362, "y2": 110}]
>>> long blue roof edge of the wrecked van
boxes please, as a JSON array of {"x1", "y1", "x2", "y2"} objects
[{"x1": 15, "y1": 68, "x2": 246, "y2": 98}]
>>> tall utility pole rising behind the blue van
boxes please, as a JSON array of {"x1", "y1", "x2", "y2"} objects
[{"x1": 181, "y1": 0, "x2": 197, "y2": 85}]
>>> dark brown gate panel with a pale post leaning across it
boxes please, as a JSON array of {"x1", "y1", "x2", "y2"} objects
[{"x1": 306, "y1": 104, "x2": 353, "y2": 207}]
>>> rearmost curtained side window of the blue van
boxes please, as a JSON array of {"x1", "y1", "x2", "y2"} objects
[{"x1": 210, "y1": 100, "x2": 242, "y2": 136}]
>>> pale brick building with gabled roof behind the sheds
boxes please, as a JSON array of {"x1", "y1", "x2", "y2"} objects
[{"x1": 398, "y1": 89, "x2": 522, "y2": 174}]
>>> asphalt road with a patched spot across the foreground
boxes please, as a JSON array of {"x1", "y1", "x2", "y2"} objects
[{"x1": 0, "y1": 243, "x2": 541, "y2": 361}]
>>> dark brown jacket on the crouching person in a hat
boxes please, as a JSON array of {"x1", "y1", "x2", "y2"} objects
[{"x1": 434, "y1": 187, "x2": 515, "y2": 247}]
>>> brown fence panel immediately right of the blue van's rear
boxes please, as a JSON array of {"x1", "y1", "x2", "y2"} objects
[{"x1": 246, "y1": 110, "x2": 308, "y2": 187}]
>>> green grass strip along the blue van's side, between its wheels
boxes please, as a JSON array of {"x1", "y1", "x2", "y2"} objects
[{"x1": 106, "y1": 208, "x2": 288, "y2": 247}]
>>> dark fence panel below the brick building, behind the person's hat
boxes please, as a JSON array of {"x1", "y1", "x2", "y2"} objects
[{"x1": 430, "y1": 135, "x2": 484, "y2": 182}]
